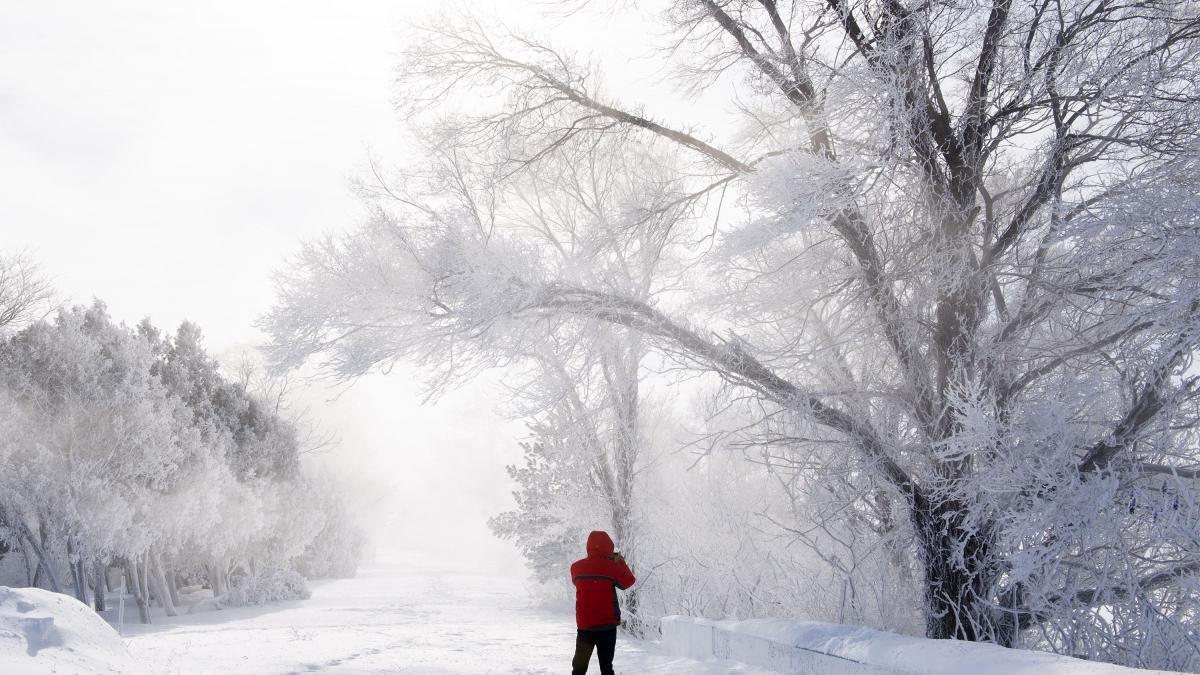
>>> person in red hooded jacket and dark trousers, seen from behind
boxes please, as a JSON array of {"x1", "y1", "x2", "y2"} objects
[{"x1": 571, "y1": 531, "x2": 637, "y2": 675}]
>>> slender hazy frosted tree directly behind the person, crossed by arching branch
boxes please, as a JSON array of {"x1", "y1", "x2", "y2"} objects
[{"x1": 477, "y1": 139, "x2": 679, "y2": 633}]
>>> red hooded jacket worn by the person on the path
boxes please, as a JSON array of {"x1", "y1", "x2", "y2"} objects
[{"x1": 571, "y1": 531, "x2": 637, "y2": 631}]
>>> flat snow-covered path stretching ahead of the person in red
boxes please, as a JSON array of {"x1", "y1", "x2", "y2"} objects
[{"x1": 117, "y1": 557, "x2": 774, "y2": 675}]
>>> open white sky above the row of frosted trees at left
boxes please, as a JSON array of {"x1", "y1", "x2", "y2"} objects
[{"x1": 0, "y1": 0, "x2": 404, "y2": 338}]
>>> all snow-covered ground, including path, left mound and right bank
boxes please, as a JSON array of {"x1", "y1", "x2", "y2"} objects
[{"x1": 7, "y1": 558, "x2": 1190, "y2": 675}]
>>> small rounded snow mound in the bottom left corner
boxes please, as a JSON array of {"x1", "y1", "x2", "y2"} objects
[{"x1": 0, "y1": 586, "x2": 140, "y2": 675}]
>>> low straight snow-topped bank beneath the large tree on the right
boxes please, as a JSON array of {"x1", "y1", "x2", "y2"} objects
[{"x1": 662, "y1": 616, "x2": 1185, "y2": 675}]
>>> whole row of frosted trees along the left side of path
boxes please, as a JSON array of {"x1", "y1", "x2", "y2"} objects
[{"x1": 0, "y1": 257, "x2": 362, "y2": 621}]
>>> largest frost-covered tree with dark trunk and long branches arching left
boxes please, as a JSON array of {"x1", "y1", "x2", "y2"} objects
[{"x1": 270, "y1": 0, "x2": 1200, "y2": 668}]
